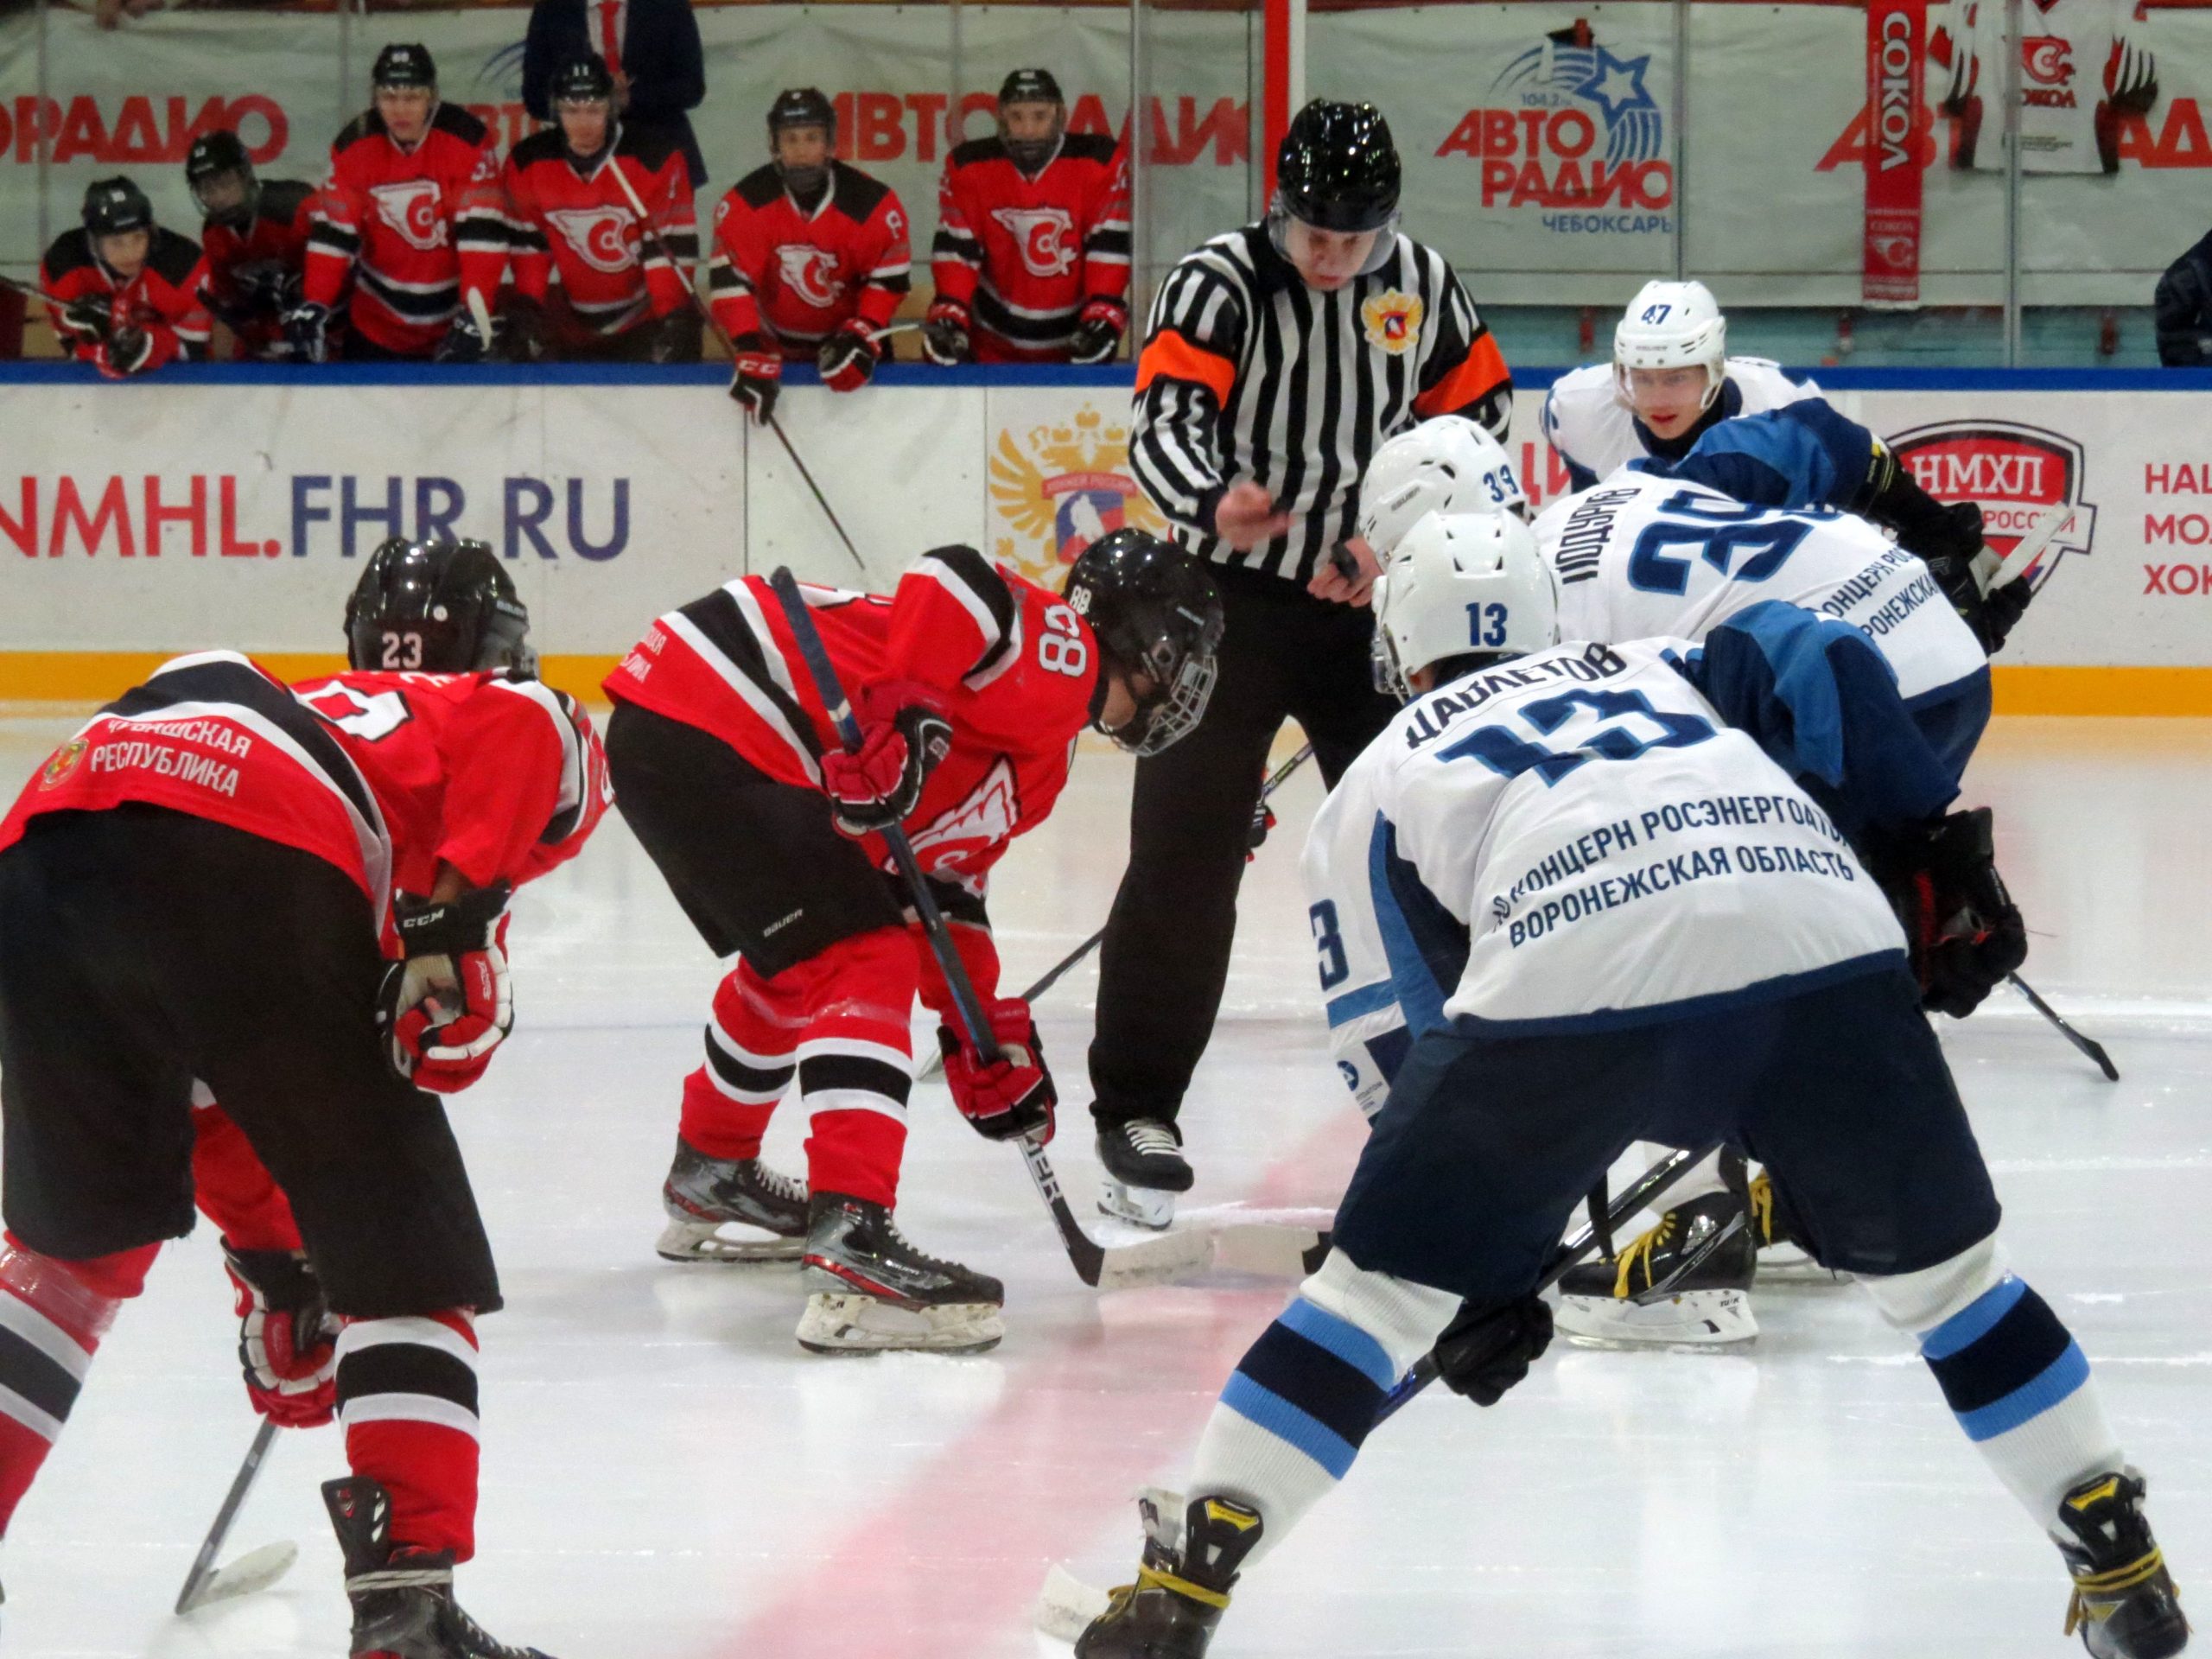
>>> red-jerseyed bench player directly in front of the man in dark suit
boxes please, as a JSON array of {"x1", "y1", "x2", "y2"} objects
[{"x1": 502, "y1": 51, "x2": 699, "y2": 363}]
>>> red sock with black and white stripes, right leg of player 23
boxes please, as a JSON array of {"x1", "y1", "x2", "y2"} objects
[{"x1": 339, "y1": 1307, "x2": 478, "y2": 1561}]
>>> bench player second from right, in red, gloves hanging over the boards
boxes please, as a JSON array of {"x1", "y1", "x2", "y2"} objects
[{"x1": 708, "y1": 86, "x2": 913, "y2": 423}]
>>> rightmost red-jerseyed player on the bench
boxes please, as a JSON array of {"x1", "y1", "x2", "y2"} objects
[{"x1": 923, "y1": 68, "x2": 1128, "y2": 365}]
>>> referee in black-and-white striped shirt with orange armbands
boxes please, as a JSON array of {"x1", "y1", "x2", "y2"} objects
[{"x1": 1090, "y1": 99, "x2": 1513, "y2": 1225}]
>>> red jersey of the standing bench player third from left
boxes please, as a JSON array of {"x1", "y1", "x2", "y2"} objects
[{"x1": 308, "y1": 104, "x2": 506, "y2": 356}]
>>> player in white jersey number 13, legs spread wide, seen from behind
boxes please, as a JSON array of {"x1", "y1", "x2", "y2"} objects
[{"x1": 1075, "y1": 513, "x2": 2188, "y2": 1659}]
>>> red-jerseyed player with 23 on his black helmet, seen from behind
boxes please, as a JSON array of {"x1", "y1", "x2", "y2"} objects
[{"x1": 0, "y1": 542, "x2": 608, "y2": 1659}]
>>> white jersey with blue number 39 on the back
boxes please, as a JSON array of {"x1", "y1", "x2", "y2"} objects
[{"x1": 1535, "y1": 469, "x2": 1988, "y2": 703}]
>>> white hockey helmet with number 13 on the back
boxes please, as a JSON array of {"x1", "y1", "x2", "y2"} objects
[{"x1": 1374, "y1": 511, "x2": 1560, "y2": 695}]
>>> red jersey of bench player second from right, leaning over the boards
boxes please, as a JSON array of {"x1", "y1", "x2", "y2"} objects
[{"x1": 708, "y1": 162, "x2": 913, "y2": 363}]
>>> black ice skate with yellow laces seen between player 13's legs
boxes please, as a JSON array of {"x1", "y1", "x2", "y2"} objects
[{"x1": 1557, "y1": 1192, "x2": 1758, "y2": 1350}]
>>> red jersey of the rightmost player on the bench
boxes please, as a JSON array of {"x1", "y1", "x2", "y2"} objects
[{"x1": 929, "y1": 133, "x2": 1130, "y2": 363}]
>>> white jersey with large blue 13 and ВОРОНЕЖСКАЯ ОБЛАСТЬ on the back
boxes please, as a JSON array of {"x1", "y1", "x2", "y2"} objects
[{"x1": 1305, "y1": 639, "x2": 1904, "y2": 1092}]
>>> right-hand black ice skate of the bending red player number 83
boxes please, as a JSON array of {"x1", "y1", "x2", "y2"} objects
[{"x1": 798, "y1": 1192, "x2": 1007, "y2": 1354}]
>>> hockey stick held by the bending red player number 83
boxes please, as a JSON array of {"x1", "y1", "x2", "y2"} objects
[{"x1": 767, "y1": 564, "x2": 1214, "y2": 1289}]
